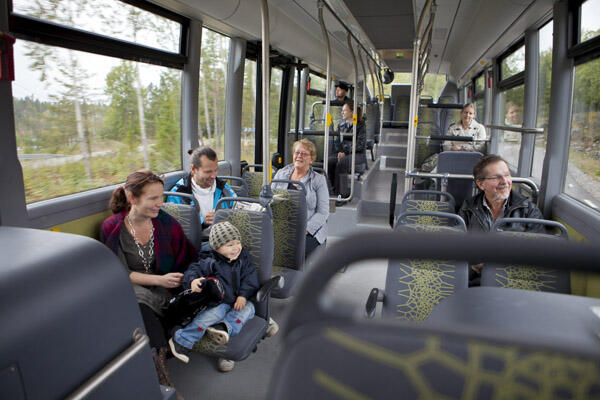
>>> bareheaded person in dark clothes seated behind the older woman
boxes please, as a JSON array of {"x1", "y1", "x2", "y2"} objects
[{"x1": 328, "y1": 101, "x2": 367, "y2": 197}]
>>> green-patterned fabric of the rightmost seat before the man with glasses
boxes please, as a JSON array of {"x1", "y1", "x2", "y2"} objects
[{"x1": 481, "y1": 232, "x2": 571, "y2": 293}]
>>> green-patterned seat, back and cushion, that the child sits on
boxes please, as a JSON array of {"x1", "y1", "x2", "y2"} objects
[{"x1": 194, "y1": 209, "x2": 273, "y2": 361}]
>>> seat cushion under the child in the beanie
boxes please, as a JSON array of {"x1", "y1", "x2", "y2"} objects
[{"x1": 194, "y1": 316, "x2": 268, "y2": 361}]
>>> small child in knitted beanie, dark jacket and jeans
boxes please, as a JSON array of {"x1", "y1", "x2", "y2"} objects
[{"x1": 169, "y1": 222, "x2": 259, "y2": 371}]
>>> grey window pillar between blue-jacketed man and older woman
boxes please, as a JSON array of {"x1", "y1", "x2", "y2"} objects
[{"x1": 225, "y1": 38, "x2": 246, "y2": 176}]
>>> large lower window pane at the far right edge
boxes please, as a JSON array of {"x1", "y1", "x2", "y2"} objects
[{"x1": 564, "y1": 58, "x2": 600, "y2": 210}]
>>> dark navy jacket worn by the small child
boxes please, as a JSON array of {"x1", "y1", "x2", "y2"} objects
[{"x1": 183, "y1": 250, "x2": 259, "y2": 305}]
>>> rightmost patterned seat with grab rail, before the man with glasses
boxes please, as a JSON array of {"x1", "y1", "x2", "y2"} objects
[{"x1": 481, "y1": 218, "x2": 571, "y2": 294}]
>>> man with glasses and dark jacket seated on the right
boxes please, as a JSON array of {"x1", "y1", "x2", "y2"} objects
[{"x1": 458, "y1": 154, "x2": 544, "y2": 286}]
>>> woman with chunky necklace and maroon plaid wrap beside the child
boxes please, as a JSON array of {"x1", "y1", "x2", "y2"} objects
[{"x1": 100, "y1": 170, "x2": 197, "y2": 396}]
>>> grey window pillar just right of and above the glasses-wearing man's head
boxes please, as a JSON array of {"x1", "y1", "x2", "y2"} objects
[{"x1": 517, "y1": 29, "x2": 539, "y2": 177}]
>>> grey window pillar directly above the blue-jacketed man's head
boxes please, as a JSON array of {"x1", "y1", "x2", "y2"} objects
[{"x1": 181, "y1": 19, "x2": 202, "y2": 170}]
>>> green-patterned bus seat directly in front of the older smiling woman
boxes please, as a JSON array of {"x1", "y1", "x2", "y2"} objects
[{"x1": 271, "y1": 183, "x2": 307, "y2": 299}]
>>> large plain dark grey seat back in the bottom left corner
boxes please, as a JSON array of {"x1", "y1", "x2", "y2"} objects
[{"x1": 0, "y1": 226, "x2": 162, "y2": 399}]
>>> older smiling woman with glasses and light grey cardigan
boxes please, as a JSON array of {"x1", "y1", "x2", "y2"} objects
[{"x1": 271, "y1": 139, "x2": 329, "y2": 257}]
